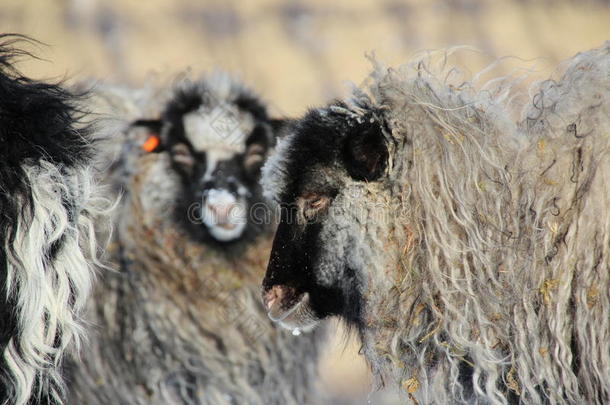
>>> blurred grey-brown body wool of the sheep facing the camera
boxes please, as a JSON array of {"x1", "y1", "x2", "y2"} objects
[{"x1": 70, "y1": 80, "x2": 323, "y2": 405}]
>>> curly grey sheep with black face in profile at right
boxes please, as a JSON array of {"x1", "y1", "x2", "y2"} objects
[{"x1": 262, "y1": 43, "x2": 610, "y2": 405}]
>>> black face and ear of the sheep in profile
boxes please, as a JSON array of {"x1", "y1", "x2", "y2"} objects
[{"x1": 263, "y1": 103, "x2": 388, "y2": 330}]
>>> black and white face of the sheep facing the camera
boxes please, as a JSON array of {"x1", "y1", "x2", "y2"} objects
[{"x1": 136, "y1": 78, "x2": 278, "y2": 244}]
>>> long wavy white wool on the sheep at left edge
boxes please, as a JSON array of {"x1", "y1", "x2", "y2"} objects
[{"x1": 3, "y1": 162, "x2": 107, "y2": 405}]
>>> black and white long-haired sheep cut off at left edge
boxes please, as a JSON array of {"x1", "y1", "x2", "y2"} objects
[{"x1": 0, "y1": 35, "x2": 107, "y2": 405}]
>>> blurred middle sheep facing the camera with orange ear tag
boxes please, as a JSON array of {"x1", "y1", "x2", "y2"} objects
[{"x1": 69, "y1": 74, "x2": 320, "y2": 405}]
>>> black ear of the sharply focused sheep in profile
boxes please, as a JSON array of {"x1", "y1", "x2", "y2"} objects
[{"x1": 344, "y1": 120, "x2": 388, "y2": 181}]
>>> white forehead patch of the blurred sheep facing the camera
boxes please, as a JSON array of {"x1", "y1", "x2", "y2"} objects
[{"x1": 182, "y1": 104, "x2": 254, "y2": 153}]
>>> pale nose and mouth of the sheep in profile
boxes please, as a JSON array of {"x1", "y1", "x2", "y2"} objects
[{"x1": 263, "y1": 285, "x2": 320, "y2": 335}]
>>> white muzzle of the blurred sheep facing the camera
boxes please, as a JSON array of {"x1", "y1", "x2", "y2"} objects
[{"x1": 201, "y1": 189, "x2": 247, "y2": 242}]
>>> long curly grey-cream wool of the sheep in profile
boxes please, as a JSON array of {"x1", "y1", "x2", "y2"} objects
[{"x1": 328, "y1": 44, "x2": 610, "y2": 405}]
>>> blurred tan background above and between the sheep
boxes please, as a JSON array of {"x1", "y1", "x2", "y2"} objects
[{"x1": 0, "y1": 0, "x2": 610, "y2": 404}]
